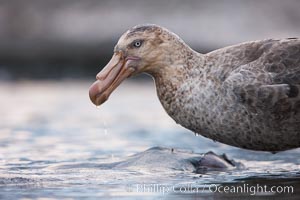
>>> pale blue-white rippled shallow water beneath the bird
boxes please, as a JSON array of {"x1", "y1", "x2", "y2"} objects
[{"x1": 0, "y1": 80, "x2": 300, "y2": 199}]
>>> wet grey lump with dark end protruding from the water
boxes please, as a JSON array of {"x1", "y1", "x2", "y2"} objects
[{"x1": 113, "y1": 147, "x2": 244, "y2": 173}]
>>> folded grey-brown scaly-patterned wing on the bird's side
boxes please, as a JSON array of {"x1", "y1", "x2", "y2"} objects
[{"x1": 224, "y1": 38, "x2": 300, "y2": 115}]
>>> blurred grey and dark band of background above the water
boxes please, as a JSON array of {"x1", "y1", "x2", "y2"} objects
[{"x1": 0, "y1": 0, "x2": 300, "y2": 80}]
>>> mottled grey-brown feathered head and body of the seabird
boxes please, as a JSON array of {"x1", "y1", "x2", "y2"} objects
[{"x1": 90, "y1": 25, "x2": 300, "y2": 151}]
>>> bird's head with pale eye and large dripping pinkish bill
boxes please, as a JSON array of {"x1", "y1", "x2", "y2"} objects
[{"x1": 89, "y1": 25, "x2": 176, "y2": 106}]
